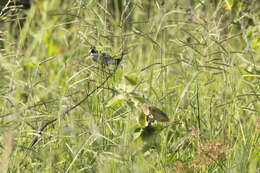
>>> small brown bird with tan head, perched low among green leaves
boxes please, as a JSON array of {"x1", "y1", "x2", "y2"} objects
[{"x1": 141, "y1": 104, "x2": 170, "y2": 122}]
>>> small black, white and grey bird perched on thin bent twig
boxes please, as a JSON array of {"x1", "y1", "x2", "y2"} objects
[{"x1": 89, "y1": 47, "x2": 122, "y2": 66}]
